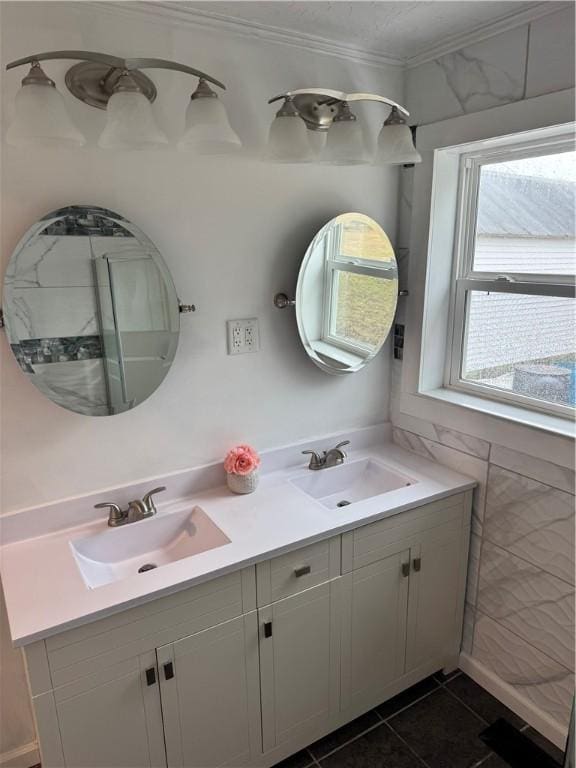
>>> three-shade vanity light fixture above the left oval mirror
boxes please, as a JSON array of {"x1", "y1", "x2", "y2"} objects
[{"x1": 6, "y1": 51, "x2": 241, "y2": 154}]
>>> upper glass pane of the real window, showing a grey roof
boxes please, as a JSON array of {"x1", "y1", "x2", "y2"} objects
[{"x1": 474, "y1": 152, "x2": 576, "y2": 275}]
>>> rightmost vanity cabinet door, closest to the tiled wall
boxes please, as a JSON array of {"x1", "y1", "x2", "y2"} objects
[{"x1": 406, "y1": 525, "x2": 465, "y2": 672}]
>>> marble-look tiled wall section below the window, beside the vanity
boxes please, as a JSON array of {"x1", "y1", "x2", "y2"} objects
[{"x1": 393, "y1": 423, "x2": 575, "y2": 725}]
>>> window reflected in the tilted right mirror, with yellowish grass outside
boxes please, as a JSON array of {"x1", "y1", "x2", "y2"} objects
[{"x1": 322, "y1": 220, "x2": 398, "y2": 357}]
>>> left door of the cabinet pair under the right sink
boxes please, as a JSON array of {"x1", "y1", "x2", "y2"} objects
[{"x1": 342, "y1": 549, "x2": 410, "y2": 716}]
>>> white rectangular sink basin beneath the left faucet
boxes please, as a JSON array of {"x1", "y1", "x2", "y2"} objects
[{"x1": 70, "y1": 507, "x2": 230, "y2": 589}]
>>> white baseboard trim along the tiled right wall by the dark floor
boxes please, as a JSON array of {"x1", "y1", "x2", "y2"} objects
[{"x1": 460, "y1": 653, "x2": 568, "y2": 749}]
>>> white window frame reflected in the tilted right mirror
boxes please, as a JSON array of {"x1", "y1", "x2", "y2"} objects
[{"x1": 321, "y1": 227, "x2": 398, "y2": 359}]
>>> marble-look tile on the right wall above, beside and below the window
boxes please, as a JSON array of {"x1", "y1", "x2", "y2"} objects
[{"x1": 392, "y1": 6, "x2": 574, "y2": 745}]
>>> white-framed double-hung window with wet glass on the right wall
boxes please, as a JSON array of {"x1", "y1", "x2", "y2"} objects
[{"x1": 446, "y1": 134, "x2": 576, "y2": 417}]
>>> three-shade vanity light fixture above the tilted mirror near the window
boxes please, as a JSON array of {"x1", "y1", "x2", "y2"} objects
[{"x1": 268, "y1": 88, "x2": 421, "y2": 165}]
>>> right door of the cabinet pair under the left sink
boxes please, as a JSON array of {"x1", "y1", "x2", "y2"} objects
[{"x1": 156, "y1": 612, "x2": 260, "y2": 768}]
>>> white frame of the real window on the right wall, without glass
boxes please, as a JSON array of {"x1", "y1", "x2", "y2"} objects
[{"x1": 444, "y1": 131, "x2": 575, "y2": 418}]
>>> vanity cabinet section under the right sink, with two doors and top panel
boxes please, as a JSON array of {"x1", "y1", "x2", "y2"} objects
[{"x1": 341, "y1": 493, "x2": 471, "y2": 720}]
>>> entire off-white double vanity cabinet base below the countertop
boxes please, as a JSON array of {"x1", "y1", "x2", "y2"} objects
[{"x1": 25, "y1": 492, "x2": 471, "y2": 768}]
